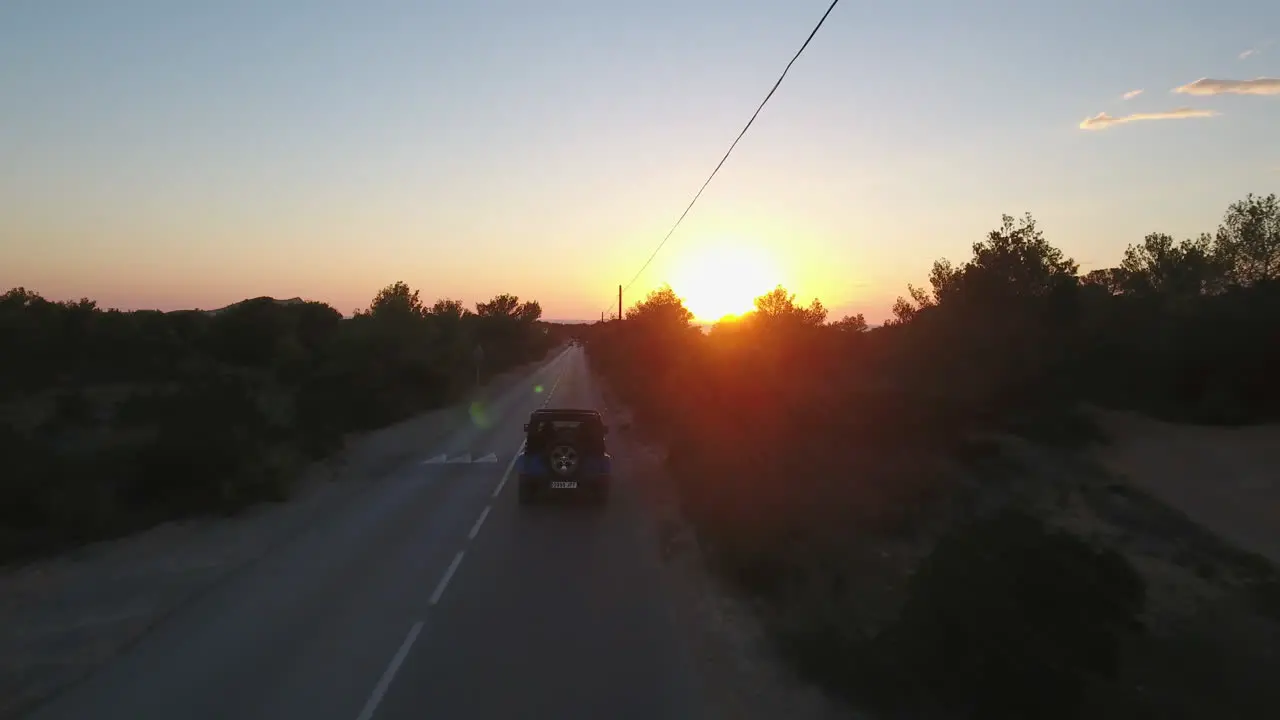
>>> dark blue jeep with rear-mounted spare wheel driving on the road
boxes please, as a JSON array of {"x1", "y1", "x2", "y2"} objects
[{"x1": 516, "y1": 409, "x2": 613, "y2": 505}]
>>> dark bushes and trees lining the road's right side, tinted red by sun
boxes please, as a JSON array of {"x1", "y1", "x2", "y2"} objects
[{"x1": 585, "y1": 195, "x2": 1280, "y2": 719}]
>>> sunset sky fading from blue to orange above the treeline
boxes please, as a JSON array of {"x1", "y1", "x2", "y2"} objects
[{"x1": 0, "y1": 0, "x2": 1280, "y2": 322}]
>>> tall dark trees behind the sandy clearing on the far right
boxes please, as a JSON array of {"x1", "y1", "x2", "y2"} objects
[{"x1": 893, "y1": 195, "x2": 1280, "y2": 424}]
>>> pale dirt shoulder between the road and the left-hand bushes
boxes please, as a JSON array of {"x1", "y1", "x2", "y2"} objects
[{"x1": 0, "y1": 354, "x2": 554, "y2": 719}]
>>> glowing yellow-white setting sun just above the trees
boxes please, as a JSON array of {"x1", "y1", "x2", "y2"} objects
[{"x1": 671, "y1": 242, "x2": 781, "y2": 322}]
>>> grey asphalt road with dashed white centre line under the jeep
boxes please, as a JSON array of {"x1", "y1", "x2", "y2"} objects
[{"x1": 24, "y1": 348, "x2": 703, "y2": 720}]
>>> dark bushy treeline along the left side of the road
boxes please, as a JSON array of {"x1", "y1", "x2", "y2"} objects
[{"x1": 0, "y1": 282, "x2": 563, "y2": 559}]
